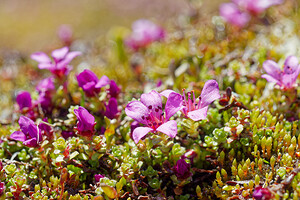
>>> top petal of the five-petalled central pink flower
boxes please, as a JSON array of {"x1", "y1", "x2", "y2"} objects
[{"x1": 141, "y1": 90, "x2": 162, "y2": 113}]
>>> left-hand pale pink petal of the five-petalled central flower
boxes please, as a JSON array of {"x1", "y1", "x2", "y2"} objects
[{"x1": 125, "y1": 101, "x2": 149, "y2": 124}]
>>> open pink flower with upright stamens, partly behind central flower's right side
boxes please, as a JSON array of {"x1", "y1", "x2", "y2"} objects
[{"x1": 161, "y1": 80, "x2": 220, "y2": 121}]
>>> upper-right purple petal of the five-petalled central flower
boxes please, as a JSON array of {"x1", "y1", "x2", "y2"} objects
[{"x1": 165, "y1": 92, "x2": 182, "y2": 120}]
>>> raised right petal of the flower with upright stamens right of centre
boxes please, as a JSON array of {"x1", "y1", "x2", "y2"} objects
[{"x1": 200, "y1": 80, "x2": 220, "y2": 108}]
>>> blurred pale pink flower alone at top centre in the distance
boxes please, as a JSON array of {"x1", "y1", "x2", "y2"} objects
[{"x1": 125, "y1": 19, "x2": 166, "y2": 50}]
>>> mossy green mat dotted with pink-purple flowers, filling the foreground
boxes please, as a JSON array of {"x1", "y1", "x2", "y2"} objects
[{"x1": 0, "y1": 0, "x2": 300, "y2": 200}]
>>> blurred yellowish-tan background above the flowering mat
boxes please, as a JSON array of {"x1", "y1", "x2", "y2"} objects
[{"x1": 0, "y1": 0, "x2": 222, "y2": 54}]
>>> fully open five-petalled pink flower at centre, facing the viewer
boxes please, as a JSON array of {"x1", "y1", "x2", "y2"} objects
[{"x1": 125, "y1": 90, "x2": 182, "y2": 143}]
